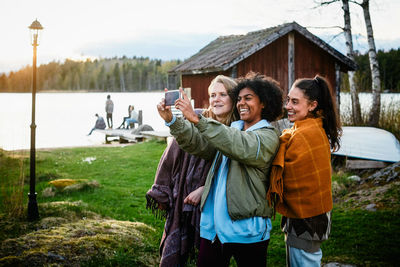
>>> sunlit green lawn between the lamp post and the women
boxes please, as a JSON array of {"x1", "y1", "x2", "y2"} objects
[{"x1": 31, "y1": 142, "x2": 165, "y2": 226}]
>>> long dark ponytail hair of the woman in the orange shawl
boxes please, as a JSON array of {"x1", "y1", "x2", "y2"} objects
[{"x1": 292, "y1": 75, "x2": 342, "y2": 151}]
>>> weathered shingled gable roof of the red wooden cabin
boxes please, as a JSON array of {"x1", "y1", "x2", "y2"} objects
[{"x1": 169, "y1": 22, "x2": 357, "y2": 74}]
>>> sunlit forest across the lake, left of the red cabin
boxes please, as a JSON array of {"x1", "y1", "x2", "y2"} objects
[{"x1": 0, "y1": 56, "x2": 181, "y2": 92}]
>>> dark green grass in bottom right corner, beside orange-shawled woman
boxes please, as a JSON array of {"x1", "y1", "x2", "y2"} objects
[{"x1": 322, "y1": 209, "x2": 400, "y2": 266}]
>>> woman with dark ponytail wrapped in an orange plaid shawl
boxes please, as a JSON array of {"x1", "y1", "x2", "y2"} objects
[{"x1": 268, "y1": 75, "x2": 341, "y2": 267}]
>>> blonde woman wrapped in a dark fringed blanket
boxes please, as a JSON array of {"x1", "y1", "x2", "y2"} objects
[{"x1": 146, "y1": 75, "x2": 237, "y2": 266}]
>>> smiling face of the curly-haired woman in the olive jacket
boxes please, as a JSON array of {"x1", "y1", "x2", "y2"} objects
[{"x1": 236, "y1": 87, "x2": 264, "y2": 130}]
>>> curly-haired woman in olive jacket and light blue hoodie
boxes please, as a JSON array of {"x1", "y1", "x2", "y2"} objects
[{"x1": 158, "y1": 73, "x2": 282, "y2": 267}]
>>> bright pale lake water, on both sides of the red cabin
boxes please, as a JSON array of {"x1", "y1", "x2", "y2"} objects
[{"x1": 0, "y1": 92, "x2": 400, "y2": 150}]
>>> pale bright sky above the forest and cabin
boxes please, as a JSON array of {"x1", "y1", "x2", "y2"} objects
[{"x1": 0, "y1": 0, "x2": 400, "y2": 73}]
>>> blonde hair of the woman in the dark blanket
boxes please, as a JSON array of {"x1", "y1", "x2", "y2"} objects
[{"x1": 203, "y1": 75, "x2": 238, "y2": 125}]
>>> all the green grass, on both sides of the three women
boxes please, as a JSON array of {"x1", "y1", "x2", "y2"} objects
[{"x1": 0, "y1": 142, "x2": 400, "y2": 266}]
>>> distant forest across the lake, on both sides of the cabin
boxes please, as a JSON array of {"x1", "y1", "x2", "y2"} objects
[{"x1": 0, "y1": 48, "x2": 400, "y2": 93}]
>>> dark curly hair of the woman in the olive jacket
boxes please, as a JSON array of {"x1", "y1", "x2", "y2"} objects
[{"x1": 233, "y1": 72, "x2": 283, "y2": 122}]
